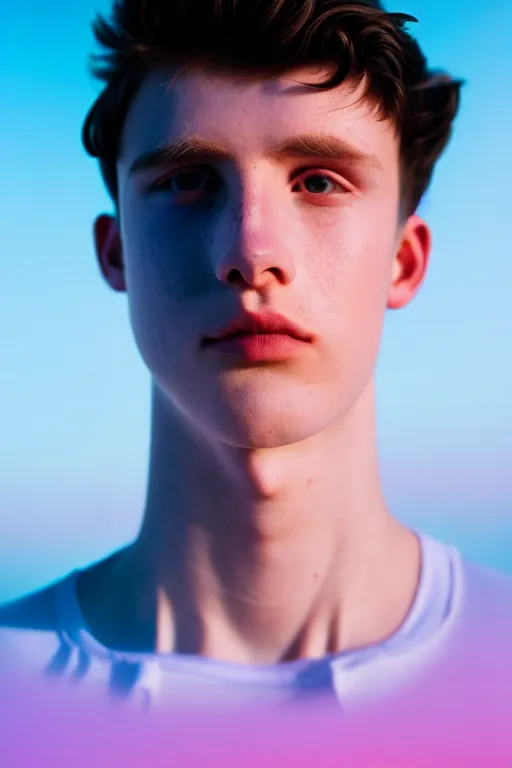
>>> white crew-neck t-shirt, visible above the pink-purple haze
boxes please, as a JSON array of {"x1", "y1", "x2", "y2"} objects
[{"x1": 0, "y1": 536, "x2": 512, "y2": 712}]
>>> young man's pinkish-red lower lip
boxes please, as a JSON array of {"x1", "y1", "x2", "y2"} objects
[{"x1": 207, "y1": 333, "x2": 307, "y2": 363}]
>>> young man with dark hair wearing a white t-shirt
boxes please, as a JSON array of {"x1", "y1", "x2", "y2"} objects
[{"x1": 2, "y1": 0, "x2": 512, "y2": 720}]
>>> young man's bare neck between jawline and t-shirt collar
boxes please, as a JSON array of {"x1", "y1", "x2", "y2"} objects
[{"x1": 83, "y1": 386, "x2": 420, "y2": 663}]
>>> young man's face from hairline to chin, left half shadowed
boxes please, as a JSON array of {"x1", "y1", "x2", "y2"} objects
[{"x1": 97, "y1": 70, "x2": 425, "y2": 448}]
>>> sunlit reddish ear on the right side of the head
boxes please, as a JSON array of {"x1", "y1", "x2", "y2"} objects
[{"x1": 387, "y1": 215, "x2": 432, "y2": 309}]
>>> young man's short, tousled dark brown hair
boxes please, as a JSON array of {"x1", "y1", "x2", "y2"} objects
[{"x1": 82, "y1": 0, "x2": 462, "y2": 217}]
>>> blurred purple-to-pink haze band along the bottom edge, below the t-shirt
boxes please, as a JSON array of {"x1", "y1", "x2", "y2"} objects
[{"x1": 0, "y1": 681, "x2": 512, "y2": 768}]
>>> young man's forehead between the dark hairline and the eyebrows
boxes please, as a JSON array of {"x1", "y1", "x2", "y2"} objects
[{"x1": 119, "y1": 67, "x2": 398, "y2": 170}]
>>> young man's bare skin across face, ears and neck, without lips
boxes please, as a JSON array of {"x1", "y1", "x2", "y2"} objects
[{"x1": 84, "y1": 68, "x2": 430, "y2": 663}]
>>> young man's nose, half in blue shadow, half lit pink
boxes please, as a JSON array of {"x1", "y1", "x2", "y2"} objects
[{"x1": 212, "y1": 186, "x2": 296, "y2": 290}]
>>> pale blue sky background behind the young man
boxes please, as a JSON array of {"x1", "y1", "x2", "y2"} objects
[{"x1": 0, "y1": 0, "x2": 512, "y2": 599}]
